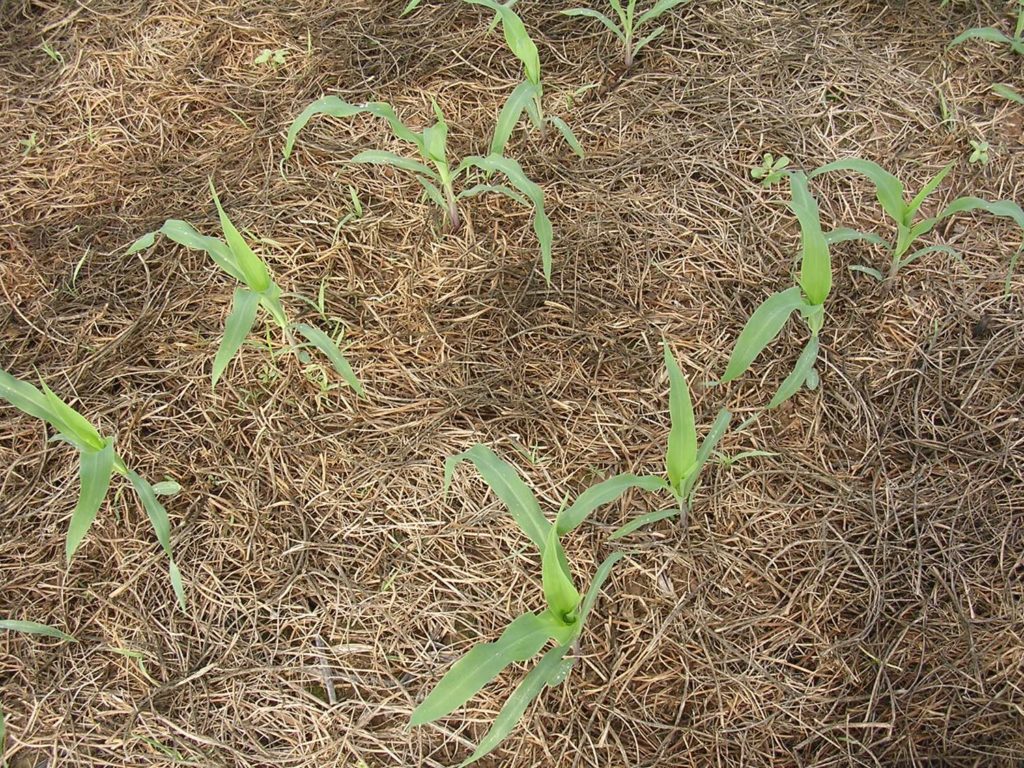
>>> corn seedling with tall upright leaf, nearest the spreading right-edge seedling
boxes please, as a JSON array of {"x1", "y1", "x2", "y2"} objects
[{"x1": 722, "y1": 171, "x2": 833, "y2": 410}]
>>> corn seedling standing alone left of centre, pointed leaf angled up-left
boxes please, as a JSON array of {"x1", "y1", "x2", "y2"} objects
[{"x1": 128, "y1": 179, "x2": 366, "y2": 396}]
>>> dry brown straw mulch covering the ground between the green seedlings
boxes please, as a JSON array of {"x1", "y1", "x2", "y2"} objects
[{"x1": 0, "y1": 0, "x2": 1024, "y2": 768}]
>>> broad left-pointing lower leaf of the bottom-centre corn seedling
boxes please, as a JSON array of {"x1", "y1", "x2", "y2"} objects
[{"x1": 409, "y1": 611, "x2": 566, "y2": 725}]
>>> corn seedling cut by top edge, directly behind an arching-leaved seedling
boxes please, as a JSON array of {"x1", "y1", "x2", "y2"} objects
[{"x1": 465, "y1": 0, "x2": 584, "y2": 158}]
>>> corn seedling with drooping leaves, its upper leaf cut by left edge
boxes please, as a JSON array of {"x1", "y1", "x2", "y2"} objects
[{"x1": 0, "y1": 369, "x2": 185, "y2": 614}]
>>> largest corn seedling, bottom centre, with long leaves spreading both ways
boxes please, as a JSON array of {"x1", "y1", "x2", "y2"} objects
[{"x1": 410, "y1": 444, "x2": 665, "y2": 766}]
